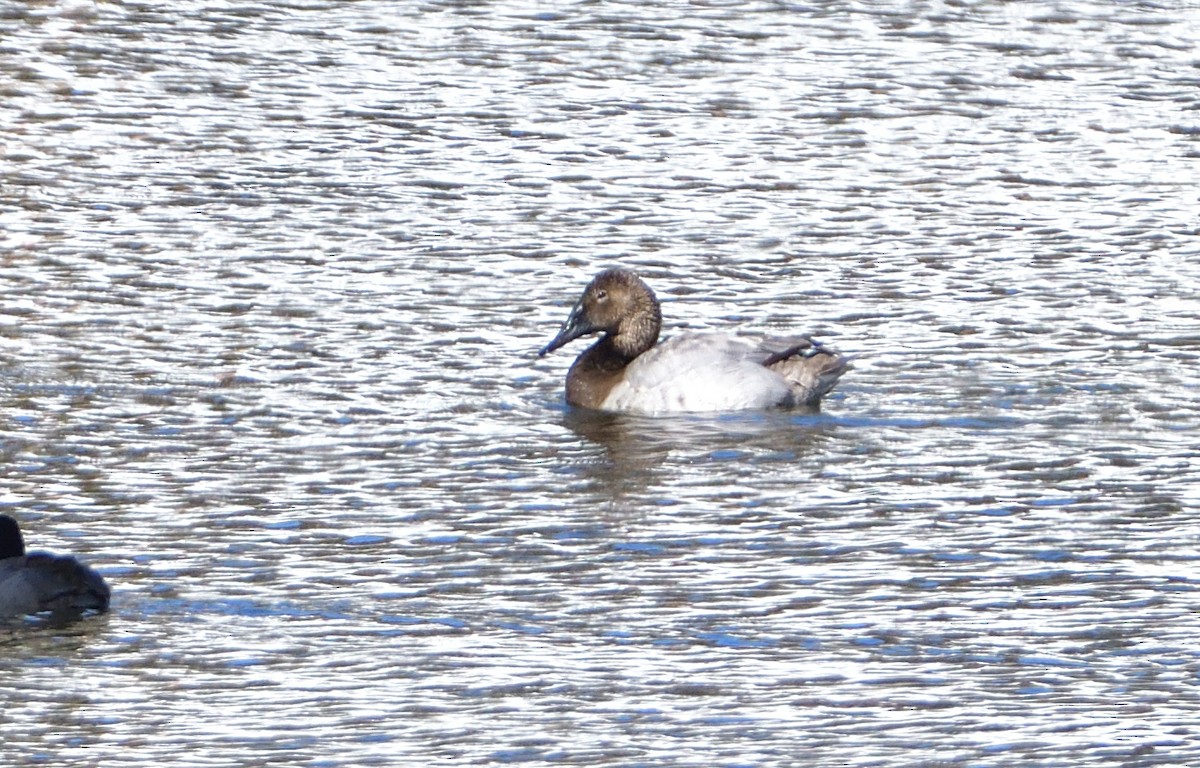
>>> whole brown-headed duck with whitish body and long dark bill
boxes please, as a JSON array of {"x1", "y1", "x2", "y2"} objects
[{"x1": 539, "y1": 269, "x2": 850, "y2": 415}]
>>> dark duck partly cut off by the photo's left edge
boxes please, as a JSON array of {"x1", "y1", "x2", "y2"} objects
[{"x1": 0, "y1": 515, "x2": 112, "y2": 618}]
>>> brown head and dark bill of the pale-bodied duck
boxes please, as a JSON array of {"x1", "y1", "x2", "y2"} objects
[{"x1": 538, "y1": 268, "x2": 662, "y2": 361}]
